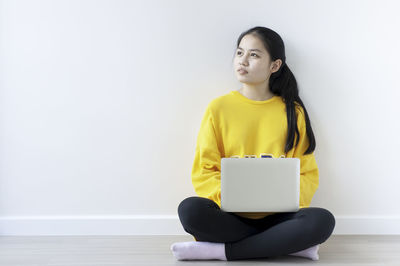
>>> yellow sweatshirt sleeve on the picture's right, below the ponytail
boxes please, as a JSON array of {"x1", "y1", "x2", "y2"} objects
[{"x1": 293, "y1": 108, "x2": 319, "y2": 208}]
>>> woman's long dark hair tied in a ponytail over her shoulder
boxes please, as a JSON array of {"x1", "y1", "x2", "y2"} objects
[{"x1": 236, "y1": 27, "x2": 315, "y2": 155}]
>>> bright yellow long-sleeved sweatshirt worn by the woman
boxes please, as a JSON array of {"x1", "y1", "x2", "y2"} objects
[{"x1": 191, "y1": 90, "x2": 319, "y2": 219}]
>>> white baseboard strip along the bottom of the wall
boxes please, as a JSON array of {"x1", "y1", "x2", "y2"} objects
[{"x1": 0, "y1": 215, "x2": 400, "y2": 236}]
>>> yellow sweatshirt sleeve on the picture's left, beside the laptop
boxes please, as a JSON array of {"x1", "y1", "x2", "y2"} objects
[{"x1": 192, "y1": 106, "x2": 221, "y2": 207}]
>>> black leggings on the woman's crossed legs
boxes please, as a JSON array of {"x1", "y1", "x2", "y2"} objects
[{"x1": 178, "y1": 196, "x2": 335, "y2": 260}]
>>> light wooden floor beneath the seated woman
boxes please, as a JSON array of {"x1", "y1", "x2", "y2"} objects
[{"x1": 0, "y1": 235, "x2": 400, "y2": 266}]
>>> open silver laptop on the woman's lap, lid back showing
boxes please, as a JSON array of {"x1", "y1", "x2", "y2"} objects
[{"x1": 221, "y1": 158, "x2": 300, "y2": 212}]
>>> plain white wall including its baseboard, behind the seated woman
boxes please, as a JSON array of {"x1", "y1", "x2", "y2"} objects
[{"x1": 0, "y1": 0, "x2": 400, "y2": 235}]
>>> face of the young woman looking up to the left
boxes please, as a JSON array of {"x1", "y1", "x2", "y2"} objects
[{"x1": 233, "y1": 34, "x2": 279, "y2": 84}]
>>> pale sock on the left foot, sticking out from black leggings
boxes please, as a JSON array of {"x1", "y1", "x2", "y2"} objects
[{"x1": 171, "y1": 241, "x2": 227, "y2": 260}]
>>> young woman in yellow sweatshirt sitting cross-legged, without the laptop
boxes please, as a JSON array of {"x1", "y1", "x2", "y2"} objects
[{"x1": 171, "y1": 27, "x2": 335, "y2": 260}]
